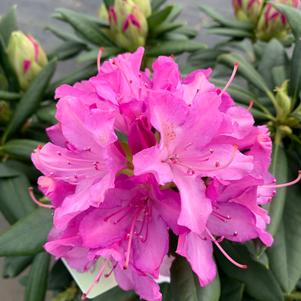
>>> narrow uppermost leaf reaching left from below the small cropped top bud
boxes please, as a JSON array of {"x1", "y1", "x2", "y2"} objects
[{"x1": 199, "y1": 4, "x2": 253, "y2": 29}]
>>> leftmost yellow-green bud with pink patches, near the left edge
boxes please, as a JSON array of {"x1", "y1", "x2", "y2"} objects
[{"x1": 7, "y1": 31, "x2": 47, "y2": 90}]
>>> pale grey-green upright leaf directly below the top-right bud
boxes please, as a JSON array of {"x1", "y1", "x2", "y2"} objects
[{"x1": 258, "y1": 39, "x2": 287, "y2": 90}]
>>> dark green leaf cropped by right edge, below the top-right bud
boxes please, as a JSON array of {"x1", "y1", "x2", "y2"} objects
[{"x1": 289, "y1": 39, "x2": 301, "y2": 103}]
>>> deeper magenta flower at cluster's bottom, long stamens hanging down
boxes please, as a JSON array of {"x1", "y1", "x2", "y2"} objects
[{"x1": 45, "y1": 175, "x2": 183, "y2": 300}]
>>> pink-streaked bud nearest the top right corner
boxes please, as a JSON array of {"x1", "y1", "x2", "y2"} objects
[{"x1": 256, "y1": 0, "x2": 300, "y2": 41}]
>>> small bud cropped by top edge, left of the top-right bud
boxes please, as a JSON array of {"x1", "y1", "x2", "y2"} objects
[{"x1": 233, "y1": 0, "x2": 264, "y2": 26}]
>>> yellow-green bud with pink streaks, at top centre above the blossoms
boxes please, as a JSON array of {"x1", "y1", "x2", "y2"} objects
[{"x1": 108, "y1": 0, "x2": 148, "y2": 50}]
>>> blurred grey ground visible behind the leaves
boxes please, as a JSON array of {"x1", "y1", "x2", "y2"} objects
[{"x1": 0, "y1": 0, "x2": 232, "y2": 301}]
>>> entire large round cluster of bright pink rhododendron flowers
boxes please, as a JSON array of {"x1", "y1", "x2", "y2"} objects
[{"x1": 32, "y1": 48, "x2": 277, "y2": 301}]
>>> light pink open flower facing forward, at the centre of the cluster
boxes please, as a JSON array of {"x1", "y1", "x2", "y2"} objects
[{"x1": 133, "y1": 88, "x2": 253, "y2": 233}]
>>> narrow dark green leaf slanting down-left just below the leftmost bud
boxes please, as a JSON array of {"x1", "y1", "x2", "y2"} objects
[{"x1": 2, "y1": 60, "x2": 56, "y2": 142}]
